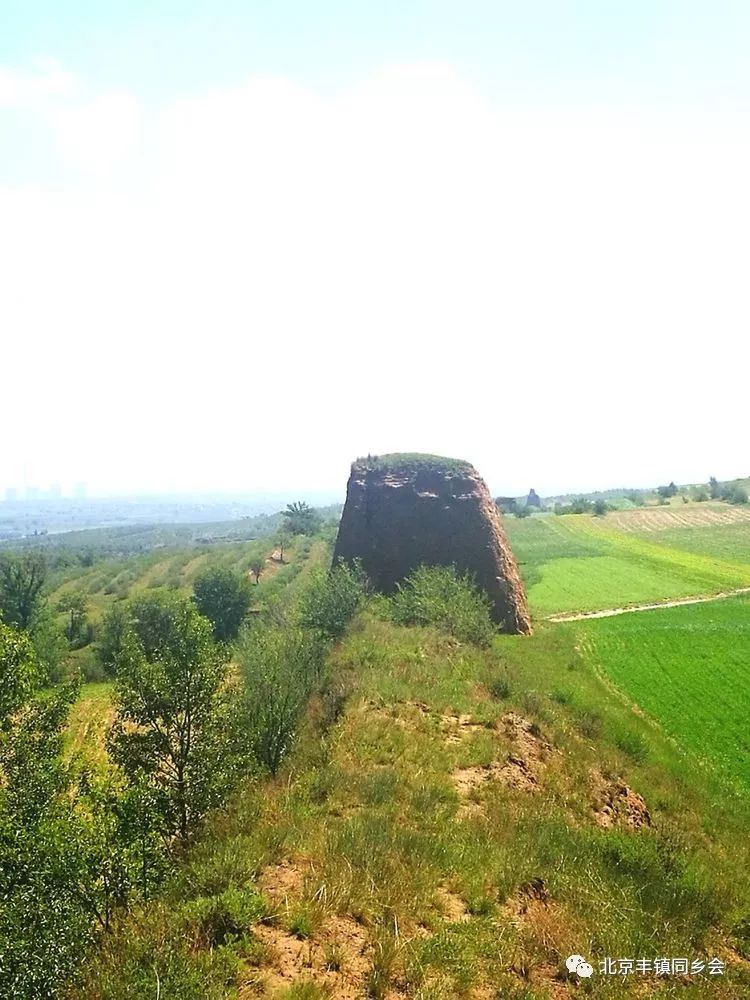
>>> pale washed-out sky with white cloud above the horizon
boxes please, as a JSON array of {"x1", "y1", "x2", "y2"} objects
[{"x1": 0, "y1": 0, "x2": 750, "y2": 495}]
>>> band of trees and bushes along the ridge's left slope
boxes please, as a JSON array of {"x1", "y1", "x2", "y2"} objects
[{"x1": 0, "y1": 532, "x2": 364, "y2": 998}]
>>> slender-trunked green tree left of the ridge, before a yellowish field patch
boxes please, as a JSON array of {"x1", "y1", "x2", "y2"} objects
[{"x1": 108, "y1": 596, "x2": 236, "y2": 841}]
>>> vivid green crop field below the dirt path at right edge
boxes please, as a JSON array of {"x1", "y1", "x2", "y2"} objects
[{"x1": 575, "y1": 597, "x2": 750, "y2": 790}]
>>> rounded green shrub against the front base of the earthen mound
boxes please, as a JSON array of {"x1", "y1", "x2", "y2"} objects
[{"x1": 390, "y1": 566, "x2": 495, "y2": 646}]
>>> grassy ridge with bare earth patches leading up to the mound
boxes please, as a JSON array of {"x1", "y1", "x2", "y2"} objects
[{"x1": 77, "y1": 614, "x2": 750, "y2": 1000}]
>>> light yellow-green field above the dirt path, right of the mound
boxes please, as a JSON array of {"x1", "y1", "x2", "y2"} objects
[{"x1": 506, "y1": 514, "x2": 750, "y2": 617}]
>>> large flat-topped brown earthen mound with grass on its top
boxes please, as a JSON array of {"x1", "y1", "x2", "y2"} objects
[{"x1": 334, "y1": 454, "x2": 531, "y2": 634}]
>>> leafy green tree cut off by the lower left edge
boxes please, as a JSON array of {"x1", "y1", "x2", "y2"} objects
[{"x1": 0, "y1": 625, "x2": 92, "y2": 1000}]
